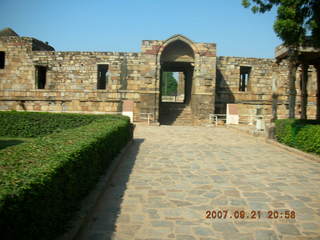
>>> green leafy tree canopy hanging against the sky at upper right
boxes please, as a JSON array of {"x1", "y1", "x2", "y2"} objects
[{"x1": 242, "y1": 0, "x2": 320, "y2": 47}]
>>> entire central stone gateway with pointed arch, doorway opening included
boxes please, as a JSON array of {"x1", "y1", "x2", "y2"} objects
[{"x1": 141, "y1": 35, "x2": 216, "y2": 125}]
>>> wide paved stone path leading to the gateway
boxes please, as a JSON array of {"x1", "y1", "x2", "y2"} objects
[{"x1": 78, "y1": 126, "x2": 320, "y2": 240}]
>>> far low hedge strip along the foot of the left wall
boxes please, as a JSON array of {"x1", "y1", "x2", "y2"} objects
[{"x1": 0, "y1": 111, "x2": 117, "y2": 137}]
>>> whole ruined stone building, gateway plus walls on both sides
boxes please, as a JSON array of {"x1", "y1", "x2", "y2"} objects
[{"x1": 0, "y1": 29, "x2": 319, "y2": 124}]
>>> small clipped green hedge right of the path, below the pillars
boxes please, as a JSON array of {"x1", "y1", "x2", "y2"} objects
[{"x1": 275, "y1": 119, "x2": 320, "y2": 154}]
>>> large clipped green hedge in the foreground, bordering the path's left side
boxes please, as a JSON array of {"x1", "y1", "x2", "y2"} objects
[{"x1": 0, "y1": 111, "x2": 132, "y2": 239}]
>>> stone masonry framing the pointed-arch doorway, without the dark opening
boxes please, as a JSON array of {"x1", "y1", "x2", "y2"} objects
[{"x1": 141, "y1": 35, "x2": 216, "y2": 120}]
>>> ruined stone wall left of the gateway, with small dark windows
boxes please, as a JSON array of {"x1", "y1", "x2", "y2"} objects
[{"x1": 0, "y1": 37, "x2": 144, "y2": 118}]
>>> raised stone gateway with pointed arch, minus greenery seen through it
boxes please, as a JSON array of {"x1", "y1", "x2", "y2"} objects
[{"x1": 141, "y1": 35, "x2": 216, "y2": 124}]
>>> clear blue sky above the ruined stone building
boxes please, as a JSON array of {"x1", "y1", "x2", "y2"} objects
[{"x1": 0, "y1": 0, "x2": 281, "y2": 58}]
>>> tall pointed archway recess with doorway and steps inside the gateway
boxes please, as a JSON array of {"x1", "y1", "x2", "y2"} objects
[{"x1": 158, "y1": 35, "x2": 196, "y2": 125}]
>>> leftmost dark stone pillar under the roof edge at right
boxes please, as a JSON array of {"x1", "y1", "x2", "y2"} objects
[{"x1": 288, "y1": 59, "x2": 298, "y2": 118}]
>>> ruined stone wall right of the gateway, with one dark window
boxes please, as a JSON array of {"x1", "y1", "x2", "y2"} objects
[{"x1": 215, "y1": 57, "x2": 316, "y2": 120}]
